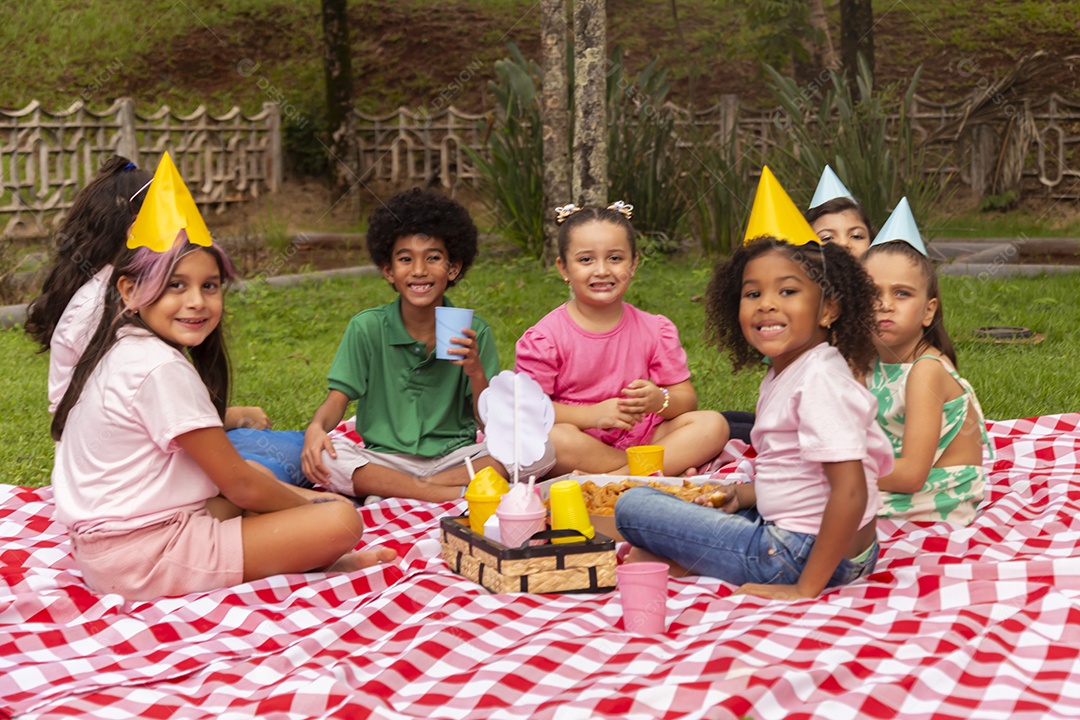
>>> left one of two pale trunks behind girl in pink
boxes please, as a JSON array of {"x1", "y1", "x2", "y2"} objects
[{"x1": 540, "y1": 0, "x2": 571, "y2": 266}]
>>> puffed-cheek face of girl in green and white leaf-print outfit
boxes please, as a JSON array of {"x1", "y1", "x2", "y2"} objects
[{"x1": 863, "y1": 252, "x2": 937, "y2": 363}]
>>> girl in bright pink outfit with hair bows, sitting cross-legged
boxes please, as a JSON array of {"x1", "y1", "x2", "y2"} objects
[{"x1": 516, "y1": 202, "x2": 728, "y2": 475}]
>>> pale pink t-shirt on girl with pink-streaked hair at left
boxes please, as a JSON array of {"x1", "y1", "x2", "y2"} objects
[{"x1": 53, "y1": 329, "x2": 221, "y2": 531}]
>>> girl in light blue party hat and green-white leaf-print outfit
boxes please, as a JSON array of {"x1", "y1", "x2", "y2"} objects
[{"x1": 863, "y1": 198, "x2": 987, "y2": 525}]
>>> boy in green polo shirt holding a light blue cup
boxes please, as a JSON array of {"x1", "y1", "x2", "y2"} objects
[{"x1": 301, "y1": 189, "x2": 554, "y2": 501}]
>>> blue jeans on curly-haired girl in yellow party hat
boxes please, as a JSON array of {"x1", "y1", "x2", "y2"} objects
[{"x1": 615, "y1": 488, "x2": 878, "y2": 587}]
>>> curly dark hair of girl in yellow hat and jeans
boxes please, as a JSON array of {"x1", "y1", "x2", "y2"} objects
[{"x1": 705, "y1": 236, "x2": 877, "y2": 376}]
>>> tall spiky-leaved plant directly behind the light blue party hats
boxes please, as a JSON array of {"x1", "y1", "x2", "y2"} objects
[{"x1": 768, "y1": 56, "x2": 942, "y2": 234}]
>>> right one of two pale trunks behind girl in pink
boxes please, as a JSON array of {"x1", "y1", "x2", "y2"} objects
[{"x1": 572, "y1": 0, "x2": 608, "y2": 206}]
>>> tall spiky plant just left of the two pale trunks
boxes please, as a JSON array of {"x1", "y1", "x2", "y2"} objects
[{"x1": 465, "y1": 42, "x2": 544, "y2": 257}]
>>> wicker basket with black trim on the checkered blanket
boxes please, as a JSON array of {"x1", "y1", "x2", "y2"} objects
[{"x1": 442, "y1": 515, "x2": 616, "y2": 593}]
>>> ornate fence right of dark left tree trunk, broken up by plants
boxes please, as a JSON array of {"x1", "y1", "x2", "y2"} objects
[{"x1": 355, "y1": 93, "x2": 1080, "y2": 202}]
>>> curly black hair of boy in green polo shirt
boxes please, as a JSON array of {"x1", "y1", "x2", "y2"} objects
[{"x1": 367, "y1": 188, "x2": 476, "y2": 287}]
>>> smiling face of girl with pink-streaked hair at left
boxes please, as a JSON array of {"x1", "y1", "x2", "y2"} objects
[{"x1": 117, "y1": 250, "x2": 225, "y2": 348}]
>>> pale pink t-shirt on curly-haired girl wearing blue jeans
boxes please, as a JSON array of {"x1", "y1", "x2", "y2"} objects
[{"x1": 751, "y1": 342, "x2": 892, "y2": 535}]
